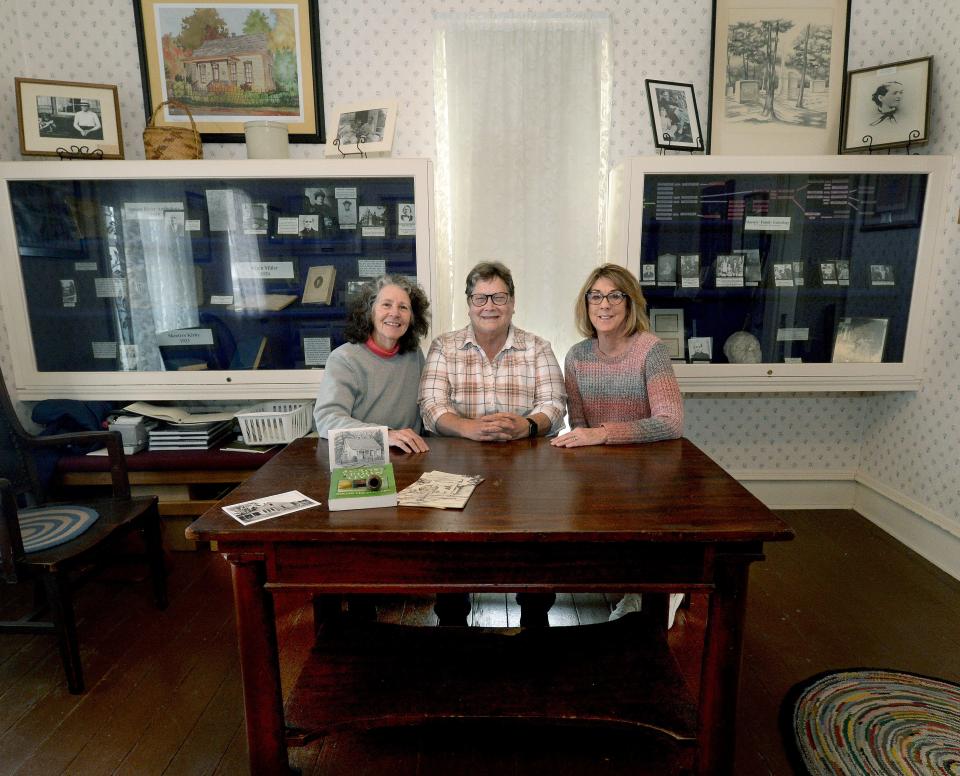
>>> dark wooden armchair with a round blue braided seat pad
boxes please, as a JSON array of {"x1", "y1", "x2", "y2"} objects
[{"x1": 0, "y1": 379, "x2": 167, "y2": 694}]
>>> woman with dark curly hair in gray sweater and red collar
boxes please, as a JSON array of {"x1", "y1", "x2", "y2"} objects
[{"x1": 313, "y1": 275, "x2": 430, "y2": 453}]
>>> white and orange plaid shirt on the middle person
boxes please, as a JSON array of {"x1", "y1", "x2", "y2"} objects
[{"x1": 420, "y1": 324, "x2": 567, "y2": 433}]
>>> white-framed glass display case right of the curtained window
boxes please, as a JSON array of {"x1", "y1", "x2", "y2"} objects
[{"x1": 607, "y1": 156, "x2": 950, "y2": 392}]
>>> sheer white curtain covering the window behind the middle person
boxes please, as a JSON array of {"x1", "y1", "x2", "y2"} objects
[{"x1": 434, "y1": 14, "x2": 611, "y2": 364}]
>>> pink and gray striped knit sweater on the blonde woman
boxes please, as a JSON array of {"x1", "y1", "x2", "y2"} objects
[{"x1": 563, "y1": 332, "x2": 683, "y2": 445}]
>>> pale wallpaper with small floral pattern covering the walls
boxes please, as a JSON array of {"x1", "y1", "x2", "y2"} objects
[{"x1": 0, "y1": 0, "x2": 960, "y2": 528}]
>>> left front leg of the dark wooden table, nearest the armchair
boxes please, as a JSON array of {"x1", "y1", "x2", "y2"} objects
[{"x1": 224, "y1": 554, "x2": 296, "y2": 776}]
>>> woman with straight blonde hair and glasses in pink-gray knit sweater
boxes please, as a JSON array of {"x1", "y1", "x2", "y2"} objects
[{"x1": 550, "y1": 264, "x2": 683, "y2": 625}]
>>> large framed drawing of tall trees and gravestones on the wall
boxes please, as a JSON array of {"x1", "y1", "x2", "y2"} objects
[{"x1": 707, "y1": 0, "x2": 850, "y2": 156}]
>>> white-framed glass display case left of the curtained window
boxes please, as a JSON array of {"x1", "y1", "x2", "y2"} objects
[{"x1": 0, "y1": 159, "x2": 433, "y2": 399}]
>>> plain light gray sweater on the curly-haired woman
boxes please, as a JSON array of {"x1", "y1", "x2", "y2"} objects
[{"x1": 313, "y1": 343, "x2": 423, "y2": 438}]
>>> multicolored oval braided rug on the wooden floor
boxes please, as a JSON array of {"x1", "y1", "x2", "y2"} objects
[{"x1": 781, "y1": 668, "x2": 960, "y2": 776}]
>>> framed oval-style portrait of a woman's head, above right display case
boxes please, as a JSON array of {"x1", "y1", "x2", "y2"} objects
[{"x1": 840, "y1": 57, "x2": 933, "y2": 154}]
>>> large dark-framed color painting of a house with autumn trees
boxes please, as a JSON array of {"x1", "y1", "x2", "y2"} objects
[{"x1": 134, "y1": 0, "x2": 326, "y2": 143}]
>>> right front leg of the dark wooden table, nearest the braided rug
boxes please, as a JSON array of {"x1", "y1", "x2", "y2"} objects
[{"x1": 697, "y1": 557, "x2": 753, "y2": 776}]
